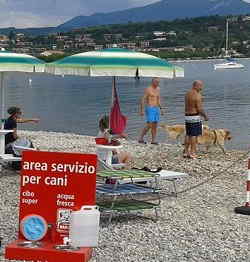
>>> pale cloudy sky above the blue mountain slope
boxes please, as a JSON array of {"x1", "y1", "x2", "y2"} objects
[{"x1": 0, "y1": 0, "x2": 158, "y2": 28}]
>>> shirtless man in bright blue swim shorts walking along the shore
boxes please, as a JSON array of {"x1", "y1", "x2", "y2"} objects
[{"x1": 138, "y1": 78, "x2": 161, "y2": 145}]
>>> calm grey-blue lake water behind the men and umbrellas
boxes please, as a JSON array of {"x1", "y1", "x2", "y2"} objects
[{"x1": 2, "y1": 59, "x2": 250, "y2": 149}]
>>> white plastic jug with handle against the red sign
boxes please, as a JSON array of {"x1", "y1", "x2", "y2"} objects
[{"x1": 69, "y1": 206, "x2": 100, "y2": 247}]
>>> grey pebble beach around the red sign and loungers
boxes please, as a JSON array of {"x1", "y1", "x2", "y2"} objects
[{"x1": 0, "y1": 131, "x2": 250, "y2": 262}]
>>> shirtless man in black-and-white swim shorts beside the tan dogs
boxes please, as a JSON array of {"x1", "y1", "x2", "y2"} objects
[{"x1": 183, "y1": 80, "x2": 208, "y2": 159}]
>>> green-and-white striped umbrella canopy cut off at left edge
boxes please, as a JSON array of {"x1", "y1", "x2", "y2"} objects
[{"x1": 0, "y1": 51, "x2": 45, "y2": 72}]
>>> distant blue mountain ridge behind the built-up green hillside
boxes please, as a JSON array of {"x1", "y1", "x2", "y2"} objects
[{"x1": 0, "y1": 0, "x2": 250, "y2": 35}]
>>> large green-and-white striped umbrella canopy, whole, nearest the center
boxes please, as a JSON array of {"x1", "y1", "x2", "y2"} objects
[{"x1": 45, "y1": 48, "x2": 184, "y2": 78}]
